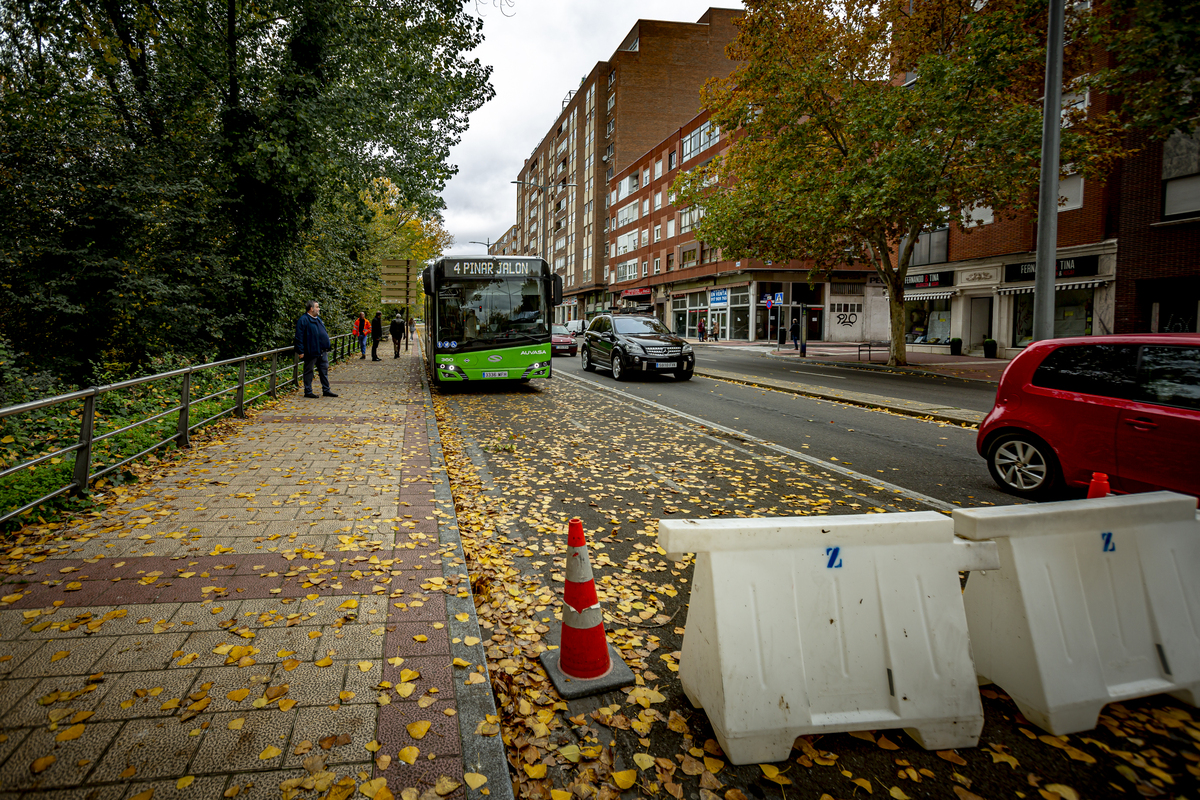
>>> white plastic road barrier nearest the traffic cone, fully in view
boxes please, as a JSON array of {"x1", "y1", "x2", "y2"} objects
[{"x1": 659, "y1": 511, "x2": 1000, "y2": 764}]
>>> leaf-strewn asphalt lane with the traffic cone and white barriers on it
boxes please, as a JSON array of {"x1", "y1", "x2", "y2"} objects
[{"x1": 434, "y1": 380, "x2": 1200, "y2": 800}]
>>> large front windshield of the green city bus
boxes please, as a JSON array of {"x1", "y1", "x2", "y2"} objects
[{"x1": 438, "y1": 276, "x2": 550, "y2": 350}]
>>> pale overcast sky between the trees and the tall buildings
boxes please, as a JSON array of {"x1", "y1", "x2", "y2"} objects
[{"x1": 442, "y1": 0, "x2": 742, "y2": 254}]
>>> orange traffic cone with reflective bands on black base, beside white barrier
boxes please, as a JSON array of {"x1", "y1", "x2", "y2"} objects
[{"x1": 541, "y1": 518, "x2": 634, "y2": 699}]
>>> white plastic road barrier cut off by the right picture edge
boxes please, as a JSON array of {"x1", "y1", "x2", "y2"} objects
[{"x1": 954, "y1": 492, "x2": 1200, "y2": 735}]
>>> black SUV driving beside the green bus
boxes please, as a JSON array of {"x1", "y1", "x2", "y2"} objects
[{"x1": 580, "y1": 314, "x2": 696, "y2": 380}]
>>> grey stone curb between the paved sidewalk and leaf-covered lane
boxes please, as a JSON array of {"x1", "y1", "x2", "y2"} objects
[{"x1": 418, "y1": 350, "x2": 514, "y2": 800}]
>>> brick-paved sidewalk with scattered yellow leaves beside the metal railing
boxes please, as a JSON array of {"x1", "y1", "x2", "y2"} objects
[{"x1": 0, "y1": 354, "x2": 501, "y2": 800}]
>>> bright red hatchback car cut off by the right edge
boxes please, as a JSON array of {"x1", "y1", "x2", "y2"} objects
[{"x1": 976, "y1": 333, "x2": 1200, "y2": 498}]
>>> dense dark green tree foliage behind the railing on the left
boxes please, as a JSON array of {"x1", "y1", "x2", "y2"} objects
[{"x1": 0, "y1": 0, "x2": 492, "y2": 384}]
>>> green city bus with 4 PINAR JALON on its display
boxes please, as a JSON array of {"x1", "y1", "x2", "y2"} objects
[{"x1": 421, "y1": 255, "x2": 563, "y2": 384}]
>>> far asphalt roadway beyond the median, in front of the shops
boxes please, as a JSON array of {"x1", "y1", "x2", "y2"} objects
[{"x1": 696, "y1": 345, "x2": 996, "y2": 411}]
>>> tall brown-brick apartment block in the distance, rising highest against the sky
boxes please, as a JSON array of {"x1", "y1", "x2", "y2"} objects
[{"x1": 509, "y1": 8, "x2": 742, "y2": 321}]
